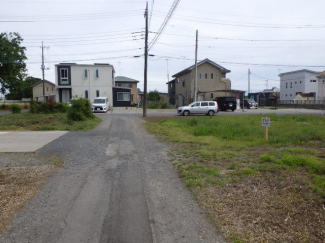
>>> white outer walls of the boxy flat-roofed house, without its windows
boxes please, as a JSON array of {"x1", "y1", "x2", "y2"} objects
[{"x1": 55, "y1": 65, "x2": 114, "y2": 107}]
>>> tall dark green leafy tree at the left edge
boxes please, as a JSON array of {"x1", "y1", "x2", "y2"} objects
[{"x1": 0, "y1": 33, "x2": 27, "y2": 96}]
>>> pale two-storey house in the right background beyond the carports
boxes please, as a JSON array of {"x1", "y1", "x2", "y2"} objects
[{"x1": 279, "y1": 69, "x2": 319, "y2": 100}]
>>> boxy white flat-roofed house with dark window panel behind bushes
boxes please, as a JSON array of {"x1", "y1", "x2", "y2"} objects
[{"x1": 55, "y1": 63, "x2": 115, "y2": 106}]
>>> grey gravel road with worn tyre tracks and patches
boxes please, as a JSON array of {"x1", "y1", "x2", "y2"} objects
[{"x1": 0, "y1": 113, "x2": 224, "y2": 243}]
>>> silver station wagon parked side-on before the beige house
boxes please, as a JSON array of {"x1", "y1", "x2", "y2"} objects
[{"x1": 177, "y1": 101, "x2": 219, "y2": 116}]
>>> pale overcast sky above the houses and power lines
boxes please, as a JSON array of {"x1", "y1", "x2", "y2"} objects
[{"x1": 0, "y1": 0, "x2": 325, "y2": 92}]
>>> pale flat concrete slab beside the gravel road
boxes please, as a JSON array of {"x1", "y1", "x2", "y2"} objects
[{"x1": 0, "y1": 131, "x2": 67, "y2": 153}]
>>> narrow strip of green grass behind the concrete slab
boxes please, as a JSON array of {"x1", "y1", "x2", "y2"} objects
[{"x1": 0, "y1": 113, "x2": 101, "y2": 131}]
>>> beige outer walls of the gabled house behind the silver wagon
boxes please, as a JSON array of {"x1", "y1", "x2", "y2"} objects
[{"x1": 175, "y1": 63, "x2": 231, "y2": 105}]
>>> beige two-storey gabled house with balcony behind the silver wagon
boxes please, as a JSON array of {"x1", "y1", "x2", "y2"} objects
[{"x1": 173, "y1": 59, "x2": 231, "y2": 106}]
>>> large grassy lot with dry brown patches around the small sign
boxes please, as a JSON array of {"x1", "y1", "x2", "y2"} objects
[{"x1": 146, "y1": 115, "x2": 325, "y2": 242}]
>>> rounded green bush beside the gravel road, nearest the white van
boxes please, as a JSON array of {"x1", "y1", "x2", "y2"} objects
[{"x1": 68, "y1": 98, "x2": 94, "y2": 121}]
